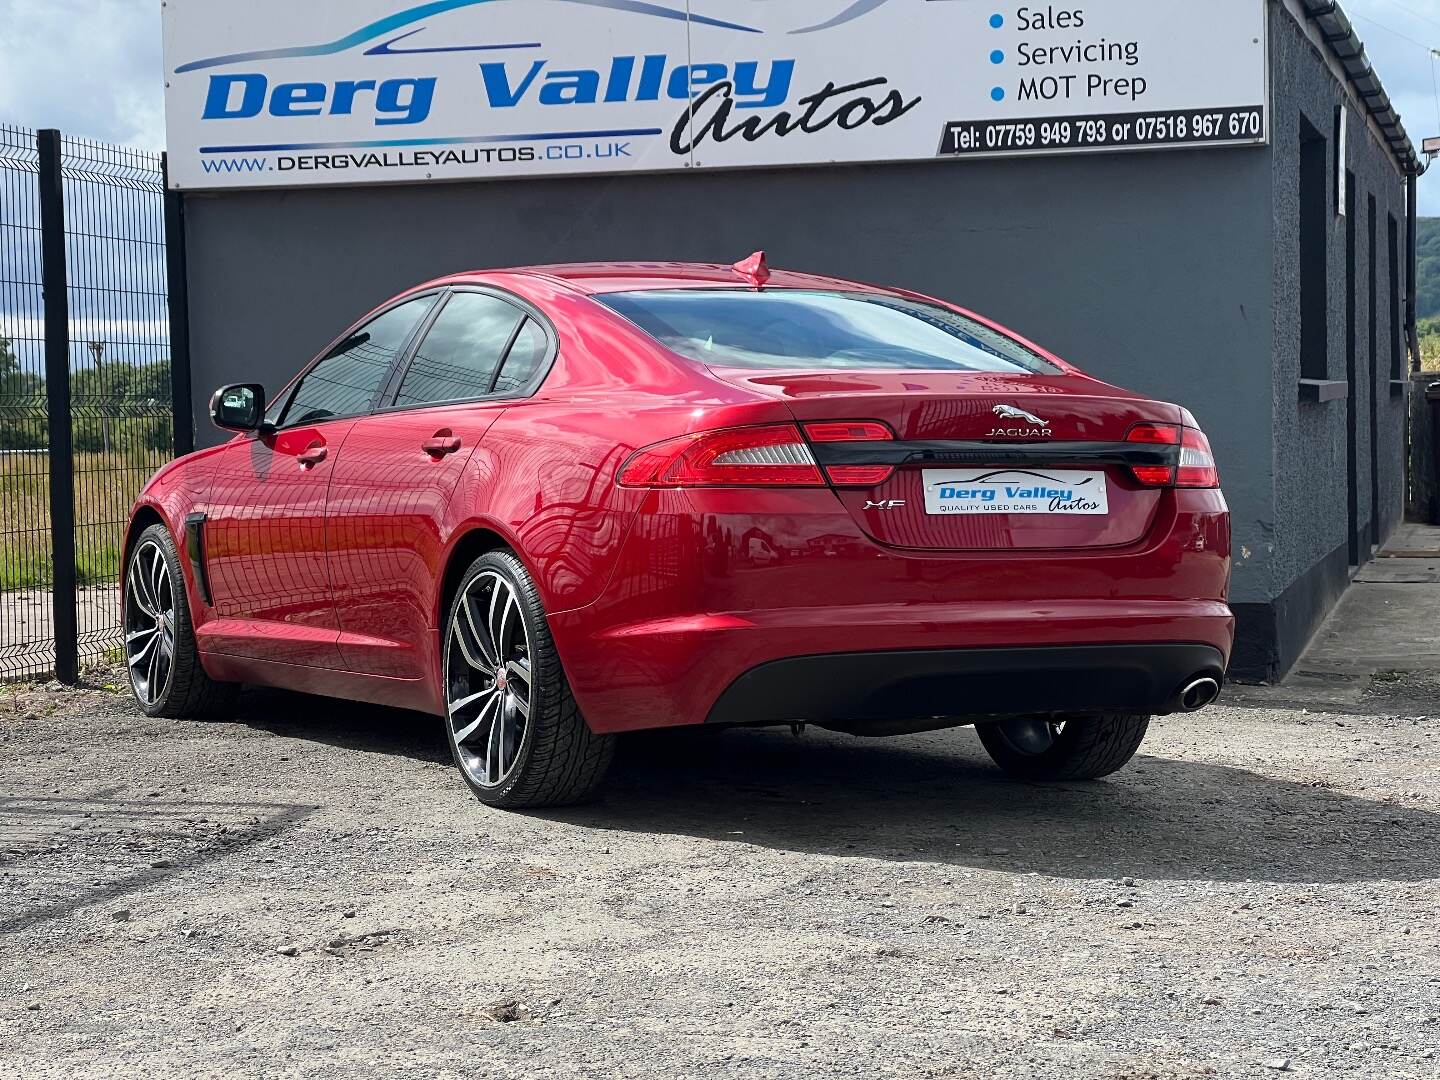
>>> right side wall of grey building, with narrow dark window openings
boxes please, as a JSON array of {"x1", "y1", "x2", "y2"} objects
[{"x1": 1255, "y1": 6, "x2": 1408, "y2": 677}]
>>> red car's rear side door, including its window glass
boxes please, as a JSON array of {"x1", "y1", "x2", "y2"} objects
[{"x1": 327, "y1": 289, "x2": 553, "y2": 680}]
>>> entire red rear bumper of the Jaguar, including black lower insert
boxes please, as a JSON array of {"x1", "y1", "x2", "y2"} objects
[{"x1": 549, "y1": 488, "x2": 1234, "y2": 733}]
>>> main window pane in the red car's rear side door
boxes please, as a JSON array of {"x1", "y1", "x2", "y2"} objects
[{"x1": 395, "y1": 292, "x2": 526, "y2": 406}]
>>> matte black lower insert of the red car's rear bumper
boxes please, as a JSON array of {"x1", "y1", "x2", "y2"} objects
[{"x1": 707, "y1": 644, "x2": 1224, "y2": 724}]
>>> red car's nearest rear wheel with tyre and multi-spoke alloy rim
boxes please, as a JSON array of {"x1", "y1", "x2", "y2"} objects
[{"x1": 441, "y1": 552, "x2": 615, "y2": 809}]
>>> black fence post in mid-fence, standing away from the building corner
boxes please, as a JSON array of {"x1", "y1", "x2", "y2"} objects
[{"x1": 35, "y1": 128, "x2": 79, "y2": 685}]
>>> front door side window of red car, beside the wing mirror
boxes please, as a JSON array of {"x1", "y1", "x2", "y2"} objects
[{"x1": 281, "y1": 297, "x2": 435, "y2": 426}]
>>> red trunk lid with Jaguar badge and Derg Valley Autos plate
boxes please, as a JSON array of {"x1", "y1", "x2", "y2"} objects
[{"x1": 713, "y1": 369, "x2": 1182, "y2": 552}]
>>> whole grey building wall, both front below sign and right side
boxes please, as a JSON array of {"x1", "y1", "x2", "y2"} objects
[{"x1": 174, "y1": 6, "x2": 1404, "y2": 675}]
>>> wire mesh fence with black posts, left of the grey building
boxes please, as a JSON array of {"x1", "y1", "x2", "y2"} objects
[{"x1": 0, "y1": 127, "x2": 174, "y2": 678}]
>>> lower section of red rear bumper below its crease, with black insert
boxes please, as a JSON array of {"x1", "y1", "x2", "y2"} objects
[{"x1": 550, "y1": 600, "x2": 1234, "y2": 733}]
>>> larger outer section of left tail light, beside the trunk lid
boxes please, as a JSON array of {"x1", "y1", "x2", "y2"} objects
[{"x1": 619, "y1": 423, "x2": 825, "y2": 488}]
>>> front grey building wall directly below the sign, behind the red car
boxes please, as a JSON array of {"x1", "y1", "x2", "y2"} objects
[{"x1": 186, "y1": 148, "x2": 1272, "y2": 587}]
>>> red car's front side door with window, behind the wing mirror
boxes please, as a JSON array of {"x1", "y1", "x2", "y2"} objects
[{"x1": 203, "y1": 295, "x2": 436, "y2": 668}]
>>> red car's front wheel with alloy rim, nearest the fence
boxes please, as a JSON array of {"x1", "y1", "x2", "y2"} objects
[{"x1": 121, "y1": 524, "x2": 240, "y2": 720}]
